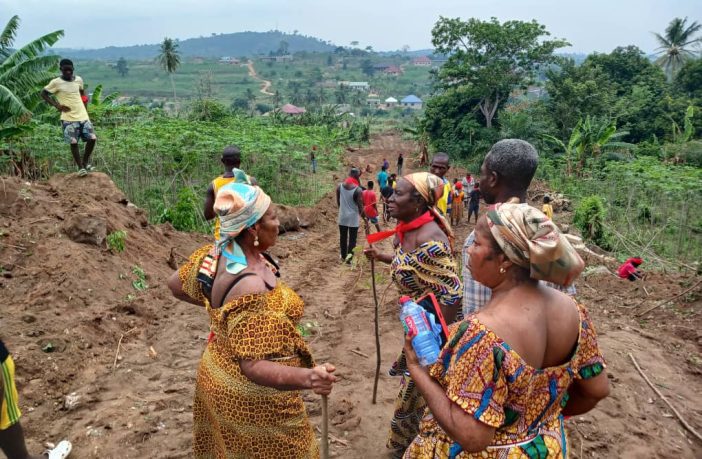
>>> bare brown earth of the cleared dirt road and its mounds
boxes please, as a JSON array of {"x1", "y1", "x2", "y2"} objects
[{"x1": 0, "y1": 135, "x2": 702, "y2": 459}]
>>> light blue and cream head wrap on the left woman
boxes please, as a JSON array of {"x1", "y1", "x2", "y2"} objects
[{"x1": 214, "y1": 182, "x2": 271, "y2": 274}]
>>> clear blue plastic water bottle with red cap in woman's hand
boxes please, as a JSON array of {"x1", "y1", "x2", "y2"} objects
[{"x1": 400, "y1": 296, "x2": 441, "y2": 366}]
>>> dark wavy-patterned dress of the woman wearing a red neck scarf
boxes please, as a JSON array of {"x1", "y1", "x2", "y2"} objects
[{"x1": 387, "y1": 241, "x2": 463, "y2": 456}]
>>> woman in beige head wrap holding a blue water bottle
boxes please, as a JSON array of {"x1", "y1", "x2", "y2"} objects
[{"x1": 405, "y1": 202, "x2": 609, "y2": 459}]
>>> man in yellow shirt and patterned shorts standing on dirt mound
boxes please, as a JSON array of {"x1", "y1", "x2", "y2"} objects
[{"x1": 41, "y1": 59, "x2": 97, "y2": 177}]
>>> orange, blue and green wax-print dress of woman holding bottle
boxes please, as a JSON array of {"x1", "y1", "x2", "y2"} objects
[{"x1": 405, "y1": 305, "x2": 605, "y2": 459}]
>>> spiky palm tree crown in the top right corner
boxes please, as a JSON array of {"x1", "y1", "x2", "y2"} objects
[{"x1": 653, "y1": 17, "x2": 702, "y2": 79}]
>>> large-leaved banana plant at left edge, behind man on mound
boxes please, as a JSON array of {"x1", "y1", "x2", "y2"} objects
[{"x1": 0, "y1": 16, "x2": 63, "y2": 139}]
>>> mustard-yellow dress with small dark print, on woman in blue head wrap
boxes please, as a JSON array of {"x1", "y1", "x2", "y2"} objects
[{"x1": 179, "y1": 246, "x2": 319, "y2": 459}]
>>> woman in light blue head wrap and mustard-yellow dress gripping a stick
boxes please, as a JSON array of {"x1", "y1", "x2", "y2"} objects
[{"x1": 169, "y1": 183, "x2": 336, "y2": 459}]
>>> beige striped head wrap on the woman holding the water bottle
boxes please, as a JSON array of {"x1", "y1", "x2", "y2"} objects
[{"x1": 487, "y1": 198, "x2": 585, "y2": 286}]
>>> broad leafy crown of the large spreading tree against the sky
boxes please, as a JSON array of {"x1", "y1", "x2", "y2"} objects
[{"x1": 431, "y1": 17, "x2": 569, "y2": 128}]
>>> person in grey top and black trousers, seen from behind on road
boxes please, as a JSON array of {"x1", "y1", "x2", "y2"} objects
[{"x1": 336, "y1": 167, "x2": 366, "y2": 264}]
